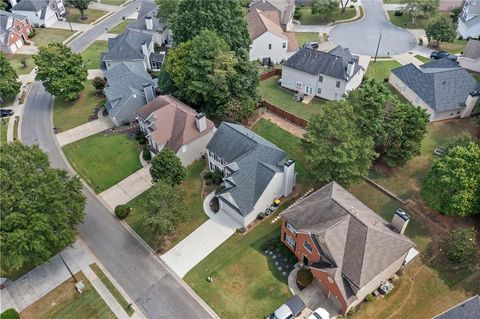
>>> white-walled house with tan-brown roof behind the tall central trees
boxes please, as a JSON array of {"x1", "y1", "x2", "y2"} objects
[{"x1": 247, "y1": 9, "x2": 298, "y2": 65}]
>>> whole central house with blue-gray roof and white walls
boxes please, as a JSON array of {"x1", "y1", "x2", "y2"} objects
[{"x1": 206, "y1": 122, "x2": 295, "y2": 226}]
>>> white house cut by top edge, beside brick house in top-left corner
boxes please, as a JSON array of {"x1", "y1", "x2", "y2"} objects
[{"x1": 10, "y1": 0, "x2": 65, "y2": 27}]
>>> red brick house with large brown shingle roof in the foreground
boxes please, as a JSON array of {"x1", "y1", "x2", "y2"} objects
[{"x1": 280, "y1": 182, "x2": 415, "y2": 314}]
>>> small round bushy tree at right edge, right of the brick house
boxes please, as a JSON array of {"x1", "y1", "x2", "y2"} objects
[{"x1": 445, "y1": 227, "x2": 477, "y2": 264}]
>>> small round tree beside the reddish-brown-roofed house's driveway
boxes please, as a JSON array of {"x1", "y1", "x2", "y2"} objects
[{"x1": 150, "y1": 148, "x2": 187, "y2": 185}]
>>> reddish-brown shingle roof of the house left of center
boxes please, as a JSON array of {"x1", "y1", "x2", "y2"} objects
[{"x1": 137, "y1": 95, "x2": 215, "y2": 152}]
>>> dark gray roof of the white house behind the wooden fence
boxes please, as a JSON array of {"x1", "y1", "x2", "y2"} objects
[{"x1": 283, "y1": 46, "x2": 360, "y2": 80}]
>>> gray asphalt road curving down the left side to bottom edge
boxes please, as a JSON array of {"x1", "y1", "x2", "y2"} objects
[{"x1": 21, "y1": 6, "x2": 216, "y2": 319}]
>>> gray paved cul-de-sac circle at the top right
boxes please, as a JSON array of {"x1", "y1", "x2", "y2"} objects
[{"x1": 330, "y1": 0, "x2": 417, "y2": 56}]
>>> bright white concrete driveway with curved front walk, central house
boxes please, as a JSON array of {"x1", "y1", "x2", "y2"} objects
[{"x1": 160, "y1": 193, "x2": 241, "y2": 278}]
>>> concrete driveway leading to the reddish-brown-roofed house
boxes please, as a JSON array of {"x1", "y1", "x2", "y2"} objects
[{"x1": 98, "y1": 165, "x2": 152, "y2": 210}]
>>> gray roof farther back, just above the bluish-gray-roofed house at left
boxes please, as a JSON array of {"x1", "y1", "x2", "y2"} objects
[{"x1": 103, "y1": 30, "x2": 153, "y2": 61}]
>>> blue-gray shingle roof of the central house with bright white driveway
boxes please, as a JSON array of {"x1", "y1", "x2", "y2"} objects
[{"x1": 207, "y1": 122, "x2": 286, "y2": 216}]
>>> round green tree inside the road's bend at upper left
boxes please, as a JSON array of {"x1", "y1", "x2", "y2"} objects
[{"x1": 33, "y1": 43, "x2": 88, "y2": 101}]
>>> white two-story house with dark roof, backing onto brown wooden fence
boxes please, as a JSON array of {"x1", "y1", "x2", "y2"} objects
[{"x1": 281, "y1": 46, "x2": 365, "y2": 101}]
